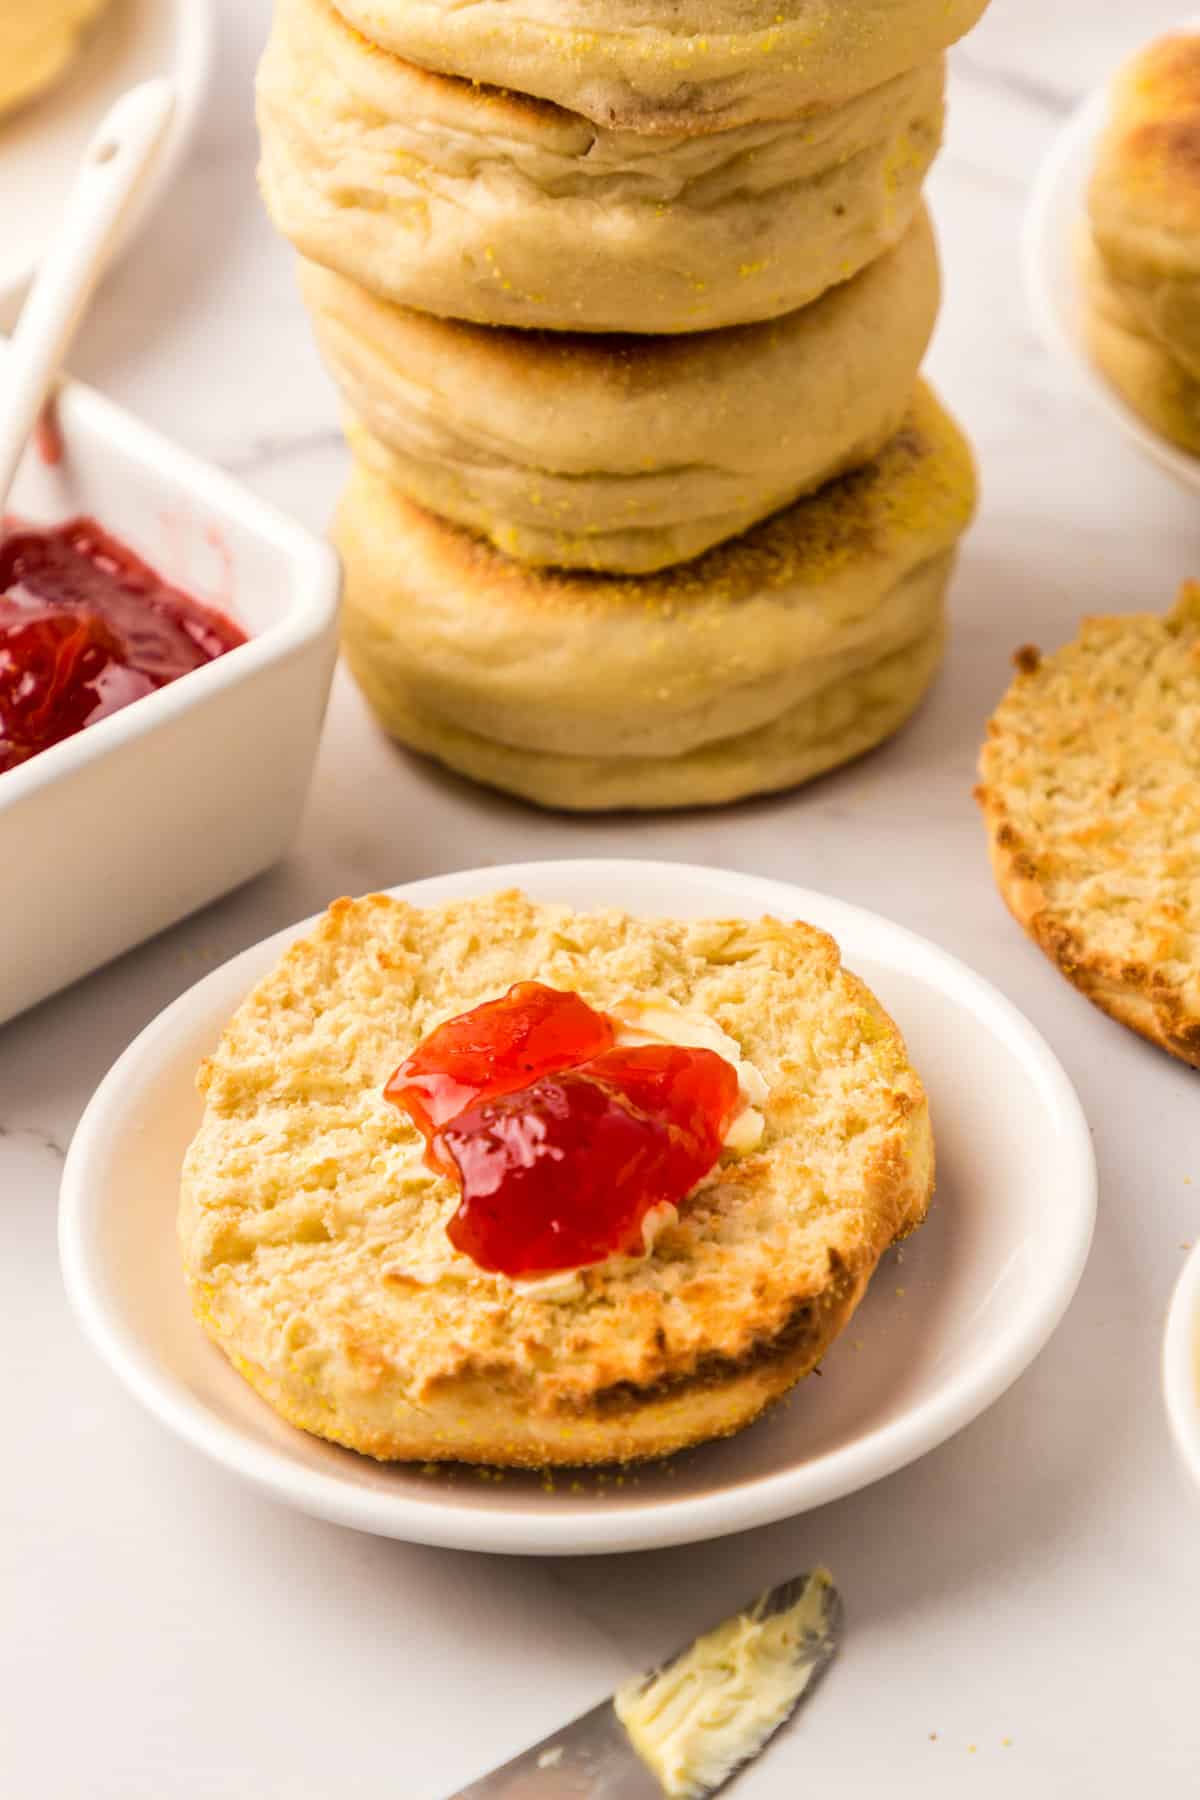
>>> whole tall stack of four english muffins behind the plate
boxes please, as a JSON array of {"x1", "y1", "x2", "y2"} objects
[{"x1": 259, "y1": 0, "x2": 986, "y2": 810}]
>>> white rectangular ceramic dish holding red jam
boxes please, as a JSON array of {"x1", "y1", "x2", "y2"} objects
[{"x1": 0, "y1": 365, "x2": 338, "y2": 1022}]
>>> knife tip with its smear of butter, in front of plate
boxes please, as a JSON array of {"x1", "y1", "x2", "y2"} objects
[{"x1": 450, "y1": 1570, "x2": 842, "y2": 1800}]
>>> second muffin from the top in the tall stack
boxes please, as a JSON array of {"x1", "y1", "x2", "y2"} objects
[{"x1": 259, "y1": 0, "x2": 943, "y2": 333}]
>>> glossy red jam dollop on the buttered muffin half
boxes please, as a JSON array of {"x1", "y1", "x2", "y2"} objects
[{"x1": 387, "y1": 981, "x2": 738, "y2": 1276}]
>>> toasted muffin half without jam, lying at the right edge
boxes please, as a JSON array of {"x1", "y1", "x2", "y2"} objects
[{"x1": 979, "y1": 585, "x2": 1200, "y2": 1067}]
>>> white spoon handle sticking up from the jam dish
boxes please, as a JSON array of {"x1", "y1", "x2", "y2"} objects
[{"x1": 0, "y1": 81, "x2": 175, "y2": 517}]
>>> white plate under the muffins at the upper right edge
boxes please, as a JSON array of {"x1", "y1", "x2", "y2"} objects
[{"x1": 1024, "y1": 16, "x2": 1200, "y2": 491}]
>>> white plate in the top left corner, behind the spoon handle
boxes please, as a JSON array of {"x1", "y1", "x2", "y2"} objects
[{"x1": 0, "y1": 0, "x2": 212, "y2": 313}]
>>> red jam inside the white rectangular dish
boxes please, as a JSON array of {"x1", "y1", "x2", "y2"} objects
[{"x1": 0, "y1": 518, "x2": 246, "y2": 774}]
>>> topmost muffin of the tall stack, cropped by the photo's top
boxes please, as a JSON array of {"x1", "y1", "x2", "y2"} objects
[{"x1": 336, "y1": 0, "x2": 986, "y2": 133}]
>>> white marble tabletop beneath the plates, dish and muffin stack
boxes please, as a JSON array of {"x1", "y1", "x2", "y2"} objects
[{"x1": 0, "y1": 0, "x2": 1200, "y2": 1800}]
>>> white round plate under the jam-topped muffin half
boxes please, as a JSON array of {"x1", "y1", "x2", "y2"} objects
[{"x1": 59, "y1": 860, "x2": 1096, "y2": 1555}]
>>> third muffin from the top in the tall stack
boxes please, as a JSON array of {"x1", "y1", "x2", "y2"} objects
[{"x1": 304, "y1": 214, "x2": 939, "y2": 574}]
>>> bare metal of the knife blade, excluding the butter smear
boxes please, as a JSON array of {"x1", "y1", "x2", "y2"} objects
[{"x1": 450, "y1": 1571, "x2": 842, "y2": 1800}]
